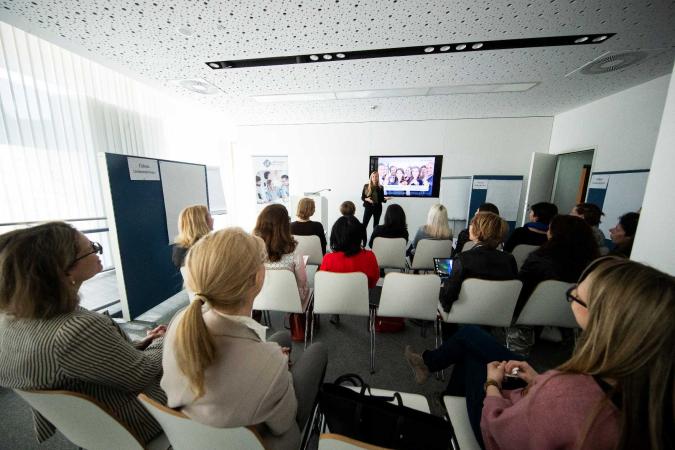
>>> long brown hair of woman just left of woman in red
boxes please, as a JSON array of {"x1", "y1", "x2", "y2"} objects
[{"x1": 253, "y1": 204, "x2": 298, "y2": 262}]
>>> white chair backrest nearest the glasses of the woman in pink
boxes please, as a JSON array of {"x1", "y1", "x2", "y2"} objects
[{"x1": 516, "y1": 280, "x2": 579, "y2": 328}]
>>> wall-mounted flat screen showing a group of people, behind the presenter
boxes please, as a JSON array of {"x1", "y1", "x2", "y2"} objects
[{"x1": 368, "y1": 155, "x2": 443, "y2": 198}]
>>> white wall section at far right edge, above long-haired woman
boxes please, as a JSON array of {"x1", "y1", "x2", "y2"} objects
[{"x1": 631, "y1": 67, "x2": 675, "y2": 275}]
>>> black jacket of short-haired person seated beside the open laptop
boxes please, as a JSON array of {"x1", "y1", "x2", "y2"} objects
[{"x1": 439, "y1": 245, "x2": 518, "y2": 312}]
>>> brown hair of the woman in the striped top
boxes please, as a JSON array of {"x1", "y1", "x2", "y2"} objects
[{"x1": 0, "y1": 222, "x2": 79, "y2": 319}]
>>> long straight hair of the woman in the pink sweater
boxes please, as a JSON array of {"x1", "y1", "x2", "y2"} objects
[{"x1": 558, "y1": 257, "x2": 675, "y2": 450}]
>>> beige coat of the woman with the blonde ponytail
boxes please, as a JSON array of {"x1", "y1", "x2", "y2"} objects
[{"x1": 161, "y1": 310, "x2": 300, "y2": 449}]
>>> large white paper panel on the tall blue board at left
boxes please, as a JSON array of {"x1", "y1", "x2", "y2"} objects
[{"x1": 159, "y1": 161, "x2": 208, "y2": 244}]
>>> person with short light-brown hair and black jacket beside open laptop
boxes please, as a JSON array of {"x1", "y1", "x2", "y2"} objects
[{"x1": 440, "y1": 212, "x2": 518, "y2": 312}]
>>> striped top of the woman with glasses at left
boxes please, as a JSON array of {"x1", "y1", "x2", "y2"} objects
[{"x1": 0, "y1": 308, "x2": 166, "y2": 443}]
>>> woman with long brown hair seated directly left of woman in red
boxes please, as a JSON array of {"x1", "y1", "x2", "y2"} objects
[{"x1": 253, "y1": 204, "x2": 310, "y2": 308}]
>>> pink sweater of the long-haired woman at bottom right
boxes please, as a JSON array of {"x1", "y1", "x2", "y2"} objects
[{"x1": 480, "y1": 370, "x2": 619, "y2": 450}]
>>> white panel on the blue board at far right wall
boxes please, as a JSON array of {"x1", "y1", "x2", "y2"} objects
[{"x1": 599, "y1": 172, "x2": 649, "y2": 237}]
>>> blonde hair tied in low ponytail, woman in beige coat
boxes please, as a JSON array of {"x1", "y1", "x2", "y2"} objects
[{"x1": 174, "y1": 228, "x2": 267, "y2": 398}]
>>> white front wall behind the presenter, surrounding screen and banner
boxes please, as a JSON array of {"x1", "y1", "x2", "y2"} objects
[{"x1": 228, "y1": 117, "x2": 552, "y2": 237}]
